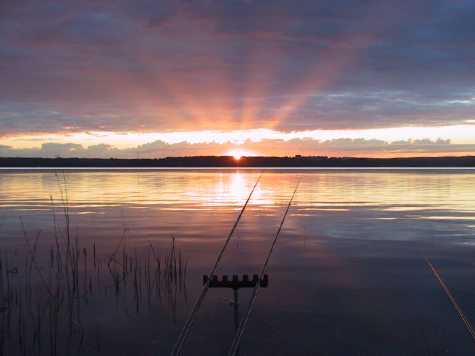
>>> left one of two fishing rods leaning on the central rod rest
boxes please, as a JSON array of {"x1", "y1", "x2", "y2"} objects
[{"x1": 170, "y1": 170, "x2": 264, "y2": 356}]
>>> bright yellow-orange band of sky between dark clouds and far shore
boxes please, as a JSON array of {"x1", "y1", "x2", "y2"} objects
[{"x1": 0, "y1": 124, "x2": 475, "y2": 159}]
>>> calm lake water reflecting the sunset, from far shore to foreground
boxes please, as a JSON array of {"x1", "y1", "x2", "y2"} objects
[{"x1": 0, "y1": 170, "x2": 475, "y2": 355}]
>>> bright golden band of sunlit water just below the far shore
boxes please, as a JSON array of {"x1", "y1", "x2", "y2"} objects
[{"x1": 0, "y1": 170, "x2": 475, "y2": 211}]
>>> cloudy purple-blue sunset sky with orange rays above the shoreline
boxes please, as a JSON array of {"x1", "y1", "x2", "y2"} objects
[{"x1": 0, "y1": 0, "x2": 475, "y2": 158}]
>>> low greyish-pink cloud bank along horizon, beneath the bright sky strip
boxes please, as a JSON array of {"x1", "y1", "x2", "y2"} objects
[{"x1": 0, "y1": 138, "x2": 475, "y2": 158}]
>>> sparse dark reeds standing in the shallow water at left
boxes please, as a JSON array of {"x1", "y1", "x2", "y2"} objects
[{"x1": 0, "y1": 178, "x2": 187, "y2": 356}]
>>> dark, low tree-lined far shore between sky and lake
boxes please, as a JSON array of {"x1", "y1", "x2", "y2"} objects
[{"x1": 0, "y1": 156, "x2": 475, "y2": 169}]
